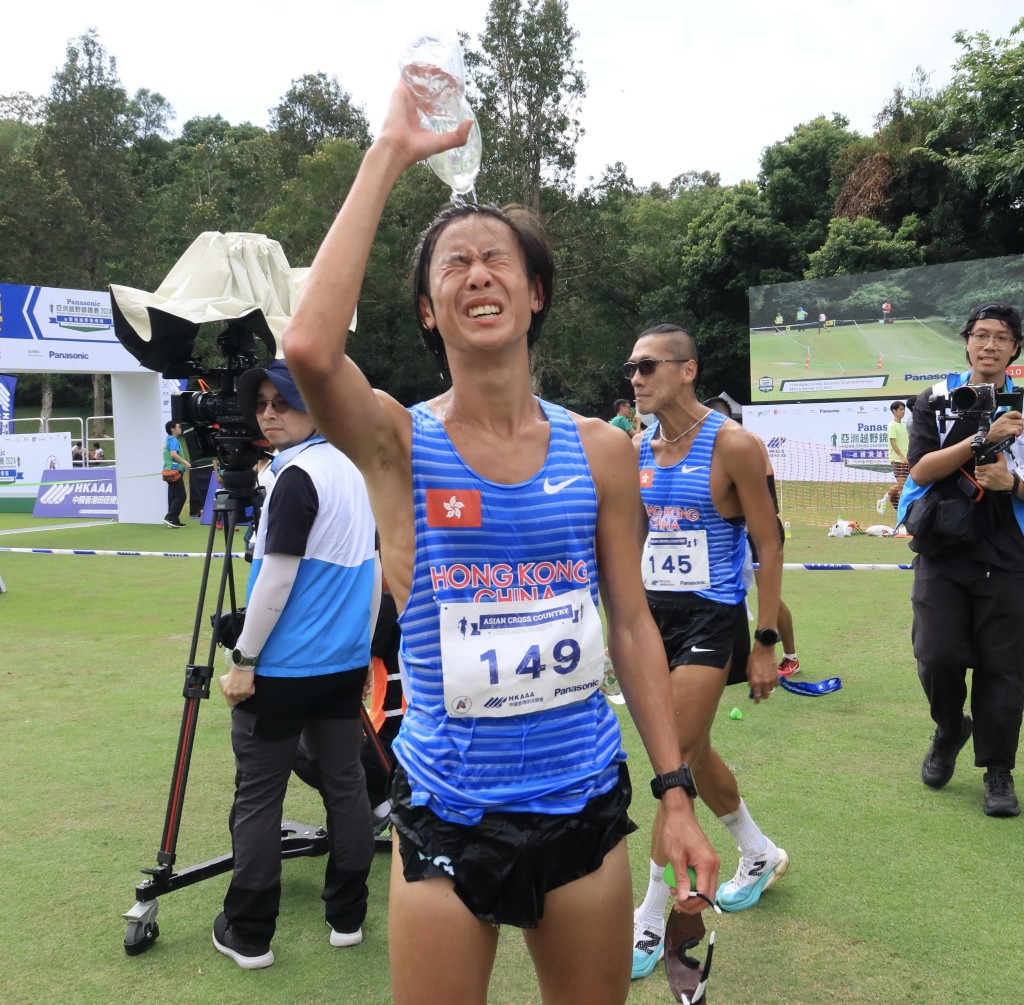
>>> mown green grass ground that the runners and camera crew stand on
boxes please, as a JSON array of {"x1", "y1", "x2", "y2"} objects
[{"x1": 0, "y1": 513, "x2": 1024, "y2": 1005}]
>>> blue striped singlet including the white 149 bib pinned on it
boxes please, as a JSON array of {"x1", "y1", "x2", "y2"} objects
[{"x1": 394, "y1": 402, "x2": 626, "y2": 825}]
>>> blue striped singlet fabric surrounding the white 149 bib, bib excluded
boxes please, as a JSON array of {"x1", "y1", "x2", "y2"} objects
[{"x1": 394, "y1": 402, "x2": 626, "y2": 825}]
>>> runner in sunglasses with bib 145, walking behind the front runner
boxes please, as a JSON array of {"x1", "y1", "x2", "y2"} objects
[{"x1": 623, "y1": 325, "x2": 790, "y2": 977}]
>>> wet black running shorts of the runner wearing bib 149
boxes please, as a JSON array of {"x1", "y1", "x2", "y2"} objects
[{"x1": 391, "y1": 763, "x2": 637, "y2": 928}]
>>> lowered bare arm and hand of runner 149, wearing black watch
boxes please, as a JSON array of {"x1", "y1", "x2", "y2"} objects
[{"x1": 580, "y1": 419, "x2": 721, "y2": 913}]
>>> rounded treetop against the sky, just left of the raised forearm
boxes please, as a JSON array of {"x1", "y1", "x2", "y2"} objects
[{"x1": 270, "y1": 73, "x2": 370, "y2": 173}]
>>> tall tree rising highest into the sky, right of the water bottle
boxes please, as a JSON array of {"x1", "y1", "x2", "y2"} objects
[{"x1": 465, "y1": 0, "x2": 587, "y2": 213}]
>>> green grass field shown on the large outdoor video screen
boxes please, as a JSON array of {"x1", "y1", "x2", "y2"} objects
[{"x1": 751, "y1": 318, "x2": 964, "y2": 403}]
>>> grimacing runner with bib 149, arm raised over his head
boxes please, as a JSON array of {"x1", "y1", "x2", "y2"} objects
[{"x1": 284, "y1": 84, "x2": 719, "y2": 1005}]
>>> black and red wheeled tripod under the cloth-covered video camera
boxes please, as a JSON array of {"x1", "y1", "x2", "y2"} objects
[{"x1": 123, "y1": 466, "x2": 328, "y2": 956}]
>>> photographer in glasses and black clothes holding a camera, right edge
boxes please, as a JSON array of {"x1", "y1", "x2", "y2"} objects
[{"x1": 898, "y1": 304, "x2": 1024, "y2": 816}]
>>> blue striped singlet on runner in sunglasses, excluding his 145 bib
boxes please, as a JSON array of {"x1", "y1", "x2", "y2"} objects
[{"x1": 640, "y1": 411, "x2": 746, "y2": 603}]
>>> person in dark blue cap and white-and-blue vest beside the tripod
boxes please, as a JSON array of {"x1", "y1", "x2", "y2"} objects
[{"x1": 213, "y1": 360, "x2": 376, "y2": 969}]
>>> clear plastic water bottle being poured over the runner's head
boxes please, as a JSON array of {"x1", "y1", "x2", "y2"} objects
[{"x1": 399, "y1": 32, "x2": 483, "y2": 196}]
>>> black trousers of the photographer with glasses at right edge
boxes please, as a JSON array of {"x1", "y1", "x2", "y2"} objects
[{"x1": 910, "y1": 555, "x2": 1024, "y2": 769}]
